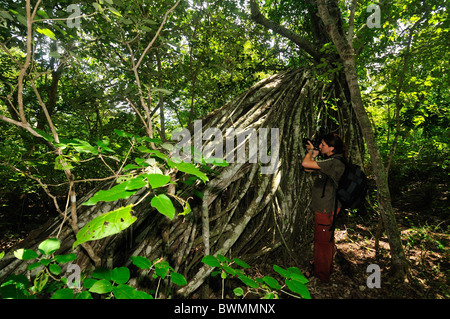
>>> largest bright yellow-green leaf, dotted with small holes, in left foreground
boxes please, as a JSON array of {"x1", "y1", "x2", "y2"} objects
[{"x1": 72, "y1": 205, "x2": 136, "y2": 249}]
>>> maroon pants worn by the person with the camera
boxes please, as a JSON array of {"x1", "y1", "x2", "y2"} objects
[{"x1": 314, "y1": 209, "x2": 339, "y2": 282}]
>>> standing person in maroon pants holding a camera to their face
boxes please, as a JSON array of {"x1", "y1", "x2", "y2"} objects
[{"x1": 302, "y1": 133, "x2": 345, "y2": 282}]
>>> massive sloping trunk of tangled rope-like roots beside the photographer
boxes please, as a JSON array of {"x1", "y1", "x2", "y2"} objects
[{"x1": 0, "y1": 69, "x2": 363, "y2": 297}]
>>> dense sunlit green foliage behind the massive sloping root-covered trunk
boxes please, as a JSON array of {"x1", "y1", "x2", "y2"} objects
[{"x1": 0, "y1": 0, "x2": 450, "y2": 300}]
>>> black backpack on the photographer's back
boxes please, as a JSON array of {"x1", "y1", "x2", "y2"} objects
[{"x1": 335, "y1": 157, "x2": 367, "y2": 209}]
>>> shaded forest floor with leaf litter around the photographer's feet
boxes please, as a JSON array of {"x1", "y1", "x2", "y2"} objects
[{"x1": 0, "y1": 168, "x2": 450, "y2": 299}]
